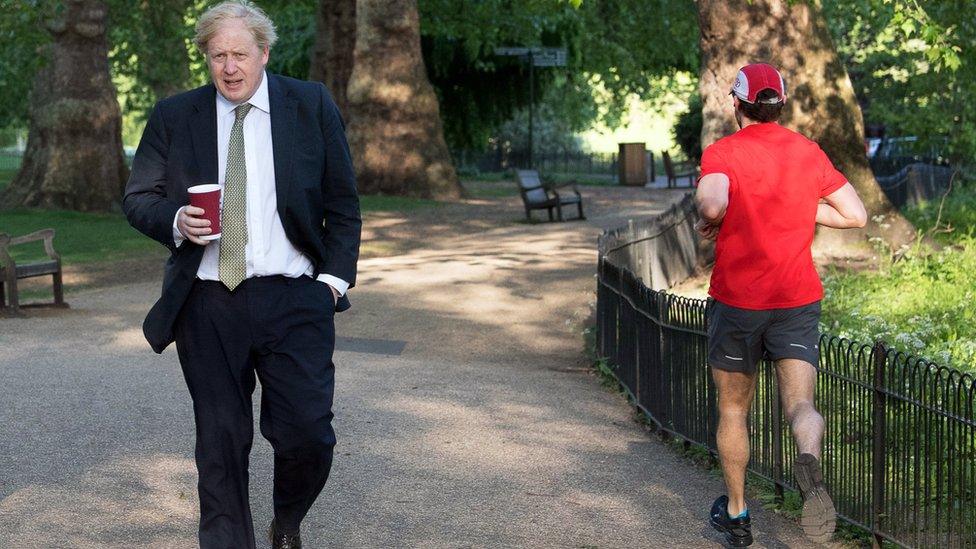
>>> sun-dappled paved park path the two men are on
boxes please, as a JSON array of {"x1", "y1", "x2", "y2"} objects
[{"x1": 0, "y1": 188, "x2": 840, "y2": 548}]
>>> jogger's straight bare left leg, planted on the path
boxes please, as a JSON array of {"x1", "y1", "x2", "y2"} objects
[{"x1": 712, "y1": 368, "x2": 756, "y2": 516}]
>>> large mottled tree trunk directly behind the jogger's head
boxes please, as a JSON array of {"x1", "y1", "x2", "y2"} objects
[{"x1": 697, "y1": 0, "x2": 915, "y2": 255}]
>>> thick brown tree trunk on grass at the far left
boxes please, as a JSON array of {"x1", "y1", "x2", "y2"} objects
[{"x1": 0, "y1": 0, "x2": 128, "y2": 211}]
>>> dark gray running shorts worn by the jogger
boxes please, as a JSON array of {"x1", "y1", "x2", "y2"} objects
[{"x1": 705, "y1": 299, "x2": 820, "y2": 374}]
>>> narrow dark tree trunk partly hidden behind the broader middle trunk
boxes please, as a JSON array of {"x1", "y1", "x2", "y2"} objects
[{"x1": 309, "y1": 0, "x2": 356, "y2": 122}]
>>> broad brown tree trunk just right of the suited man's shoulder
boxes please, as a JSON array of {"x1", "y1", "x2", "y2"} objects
[{"x1": 347, "y1": 0, "x2": 461, "y2": 198}]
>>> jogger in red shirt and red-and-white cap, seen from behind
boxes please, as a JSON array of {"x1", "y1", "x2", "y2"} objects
[{"x1": 696, "y1": 63, "x2": 867, "y2": 547}]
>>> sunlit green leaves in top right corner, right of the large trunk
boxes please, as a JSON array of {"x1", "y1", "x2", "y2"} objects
[{"x1": 823, "y1": 0, "x2": 976, "y2": 160}]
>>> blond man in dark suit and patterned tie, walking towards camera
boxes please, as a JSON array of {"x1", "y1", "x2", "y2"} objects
[{"x1": 123, "y1": 1, "x2": 361, "y2": 549}]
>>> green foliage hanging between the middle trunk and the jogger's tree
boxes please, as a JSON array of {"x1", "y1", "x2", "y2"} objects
[{"x1": 420, "y1": 0, "x2": 698, "y2": 149}]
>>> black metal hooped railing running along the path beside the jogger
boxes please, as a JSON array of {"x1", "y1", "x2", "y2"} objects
[{"x1": 597, "y1": 226, "x2": 976, "y2": 548}]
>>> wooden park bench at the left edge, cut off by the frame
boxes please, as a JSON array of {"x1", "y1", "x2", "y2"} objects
[{"x1": 0, "y1": 229, "x2": 68, "y2": 315}]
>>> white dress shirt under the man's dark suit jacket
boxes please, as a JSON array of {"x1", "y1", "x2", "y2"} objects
[{"x1": 173, "y1": 73, "x2": 349, "y2": 295}]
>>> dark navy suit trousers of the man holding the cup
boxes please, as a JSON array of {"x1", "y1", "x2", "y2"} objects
[{"x1": 175, "y1": 276, "x2": 335, "y2": 549}]
